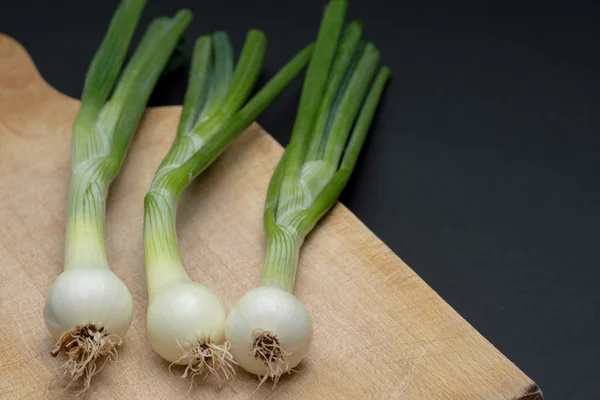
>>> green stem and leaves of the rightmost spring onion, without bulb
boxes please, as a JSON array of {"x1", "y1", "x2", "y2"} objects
[{"x1": 260, "y1": 0, "x2": 390, "y2": 292}]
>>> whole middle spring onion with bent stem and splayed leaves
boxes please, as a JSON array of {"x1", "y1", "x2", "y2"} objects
[{"x1": 144, "y1": 30, "x2": 312, "y2": 384}]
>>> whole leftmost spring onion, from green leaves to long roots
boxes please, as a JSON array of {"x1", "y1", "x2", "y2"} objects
[{"x1": 44, "y1": 0, "x2": 192, "y2": 390}]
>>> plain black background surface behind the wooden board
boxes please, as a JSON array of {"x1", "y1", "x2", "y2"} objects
[{"x1": 0, "y1": 0, "x2": 600, "y2": 399}]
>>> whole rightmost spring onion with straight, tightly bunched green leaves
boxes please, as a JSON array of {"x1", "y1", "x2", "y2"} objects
[{"x1": 226, "y1": 0, "x2": 390, "y2": 385}]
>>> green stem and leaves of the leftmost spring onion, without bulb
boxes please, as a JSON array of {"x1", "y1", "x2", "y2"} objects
[{"x1": 65, "y1": 5, "x2": 191, "y2": 269}]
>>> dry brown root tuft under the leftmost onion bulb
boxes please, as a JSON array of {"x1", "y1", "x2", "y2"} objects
[{"x1": 50, "y1": 324, "x2": 123, "y2": 393}]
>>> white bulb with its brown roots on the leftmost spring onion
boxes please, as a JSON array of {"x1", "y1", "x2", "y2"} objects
[{"x1": 44, "y1": 264, "x2": 133, "y2": 391}]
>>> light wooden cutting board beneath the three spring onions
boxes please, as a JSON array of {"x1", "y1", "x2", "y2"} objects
[{"x1": 0, "y1": 35, "x2": 542, "y2": 400}]
